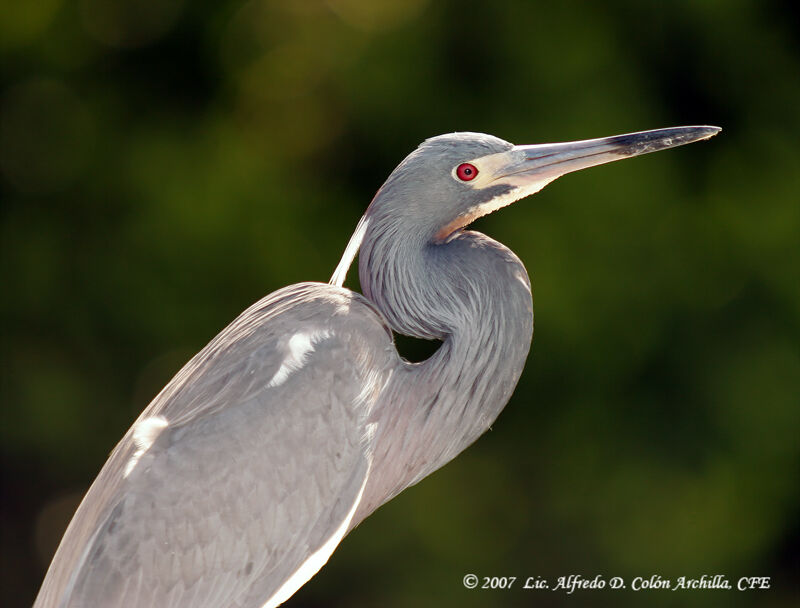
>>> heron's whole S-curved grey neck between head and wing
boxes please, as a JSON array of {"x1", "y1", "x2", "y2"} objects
[{"x1": 359, "y1": 230, "x2": 533, "y2": 517}]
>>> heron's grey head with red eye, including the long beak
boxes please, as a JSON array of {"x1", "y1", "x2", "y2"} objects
[{"x1": 371, "y1": 126, "x2": 720, "y2": 243}]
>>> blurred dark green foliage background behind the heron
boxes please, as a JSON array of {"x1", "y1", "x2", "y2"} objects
[{"x1": 0, "y1": 0, "x2": 800, "y2": 608}]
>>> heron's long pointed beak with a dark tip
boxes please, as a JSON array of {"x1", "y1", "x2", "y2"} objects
[{"x1": 487, "y1": 126, "x2": 722, "y2": 189}]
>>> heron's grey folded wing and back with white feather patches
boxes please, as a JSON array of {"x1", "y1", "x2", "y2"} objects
[{"x1": 35, "y1": 283, "x2": 398, "y2": 608}]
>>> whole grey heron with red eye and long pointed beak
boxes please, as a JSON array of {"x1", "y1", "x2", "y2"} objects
[{"x1": 35, "y1": 126, "x2": 720, "y2": 608}]
